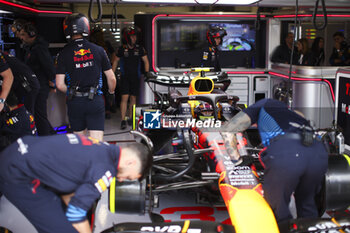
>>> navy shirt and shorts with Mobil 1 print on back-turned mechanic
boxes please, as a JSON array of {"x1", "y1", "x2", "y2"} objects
[{"x1": 56, "y1": 39, "x2": 111, "y2": 131}]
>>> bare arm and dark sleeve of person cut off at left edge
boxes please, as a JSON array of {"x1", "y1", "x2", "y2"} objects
[{"x1": 0, "y1": 52, "x2": 14, "y2": 112}]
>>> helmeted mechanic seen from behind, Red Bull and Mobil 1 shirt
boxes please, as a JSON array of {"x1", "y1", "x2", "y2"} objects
[{"x1": 56, "y1": 13, "x2": 116, "y2": 141}]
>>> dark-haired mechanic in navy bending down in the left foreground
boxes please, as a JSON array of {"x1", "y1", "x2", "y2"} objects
[{"x1": 0, "y1": 134, "x2": 152, "y2": 233}]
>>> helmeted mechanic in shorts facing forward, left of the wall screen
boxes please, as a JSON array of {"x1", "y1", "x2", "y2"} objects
[{"x1": 112, "y1": 27, "x2": 149, "y2": 129}]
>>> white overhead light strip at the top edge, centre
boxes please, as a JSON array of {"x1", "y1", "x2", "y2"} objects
[{"x1": 122, "y1": 0, "x2": 261, "y2": 5}]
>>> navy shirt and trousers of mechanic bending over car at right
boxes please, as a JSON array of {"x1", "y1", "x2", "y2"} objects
[{"x1": 243, "y1": 99, "x2": 328, "y2": 222}]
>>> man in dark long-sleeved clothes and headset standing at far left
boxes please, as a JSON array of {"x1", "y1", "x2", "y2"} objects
[{"x1": 20, "y1": 23, "x2": 55, "y2": 136}]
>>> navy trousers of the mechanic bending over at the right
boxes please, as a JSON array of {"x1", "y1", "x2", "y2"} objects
[{"x1": 262, "y1": 138, "x2": 328, "y2": 222}]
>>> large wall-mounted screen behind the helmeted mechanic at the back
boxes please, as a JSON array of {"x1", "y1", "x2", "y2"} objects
[{"x1": 155, "y1": 15, "x2": 266, "y2": 68}]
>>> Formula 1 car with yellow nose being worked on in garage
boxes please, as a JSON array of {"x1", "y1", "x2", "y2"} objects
[{"x1": 104, "y1": 69, "x2": 350, "y2": 233}]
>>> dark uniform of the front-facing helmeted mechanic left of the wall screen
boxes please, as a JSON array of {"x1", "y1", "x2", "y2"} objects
[{"x1": 117, "y1": 45, "x2": 147, "y2": 96}]
